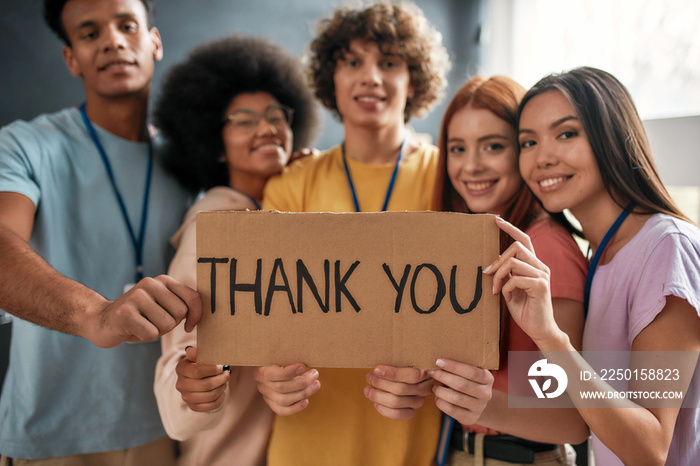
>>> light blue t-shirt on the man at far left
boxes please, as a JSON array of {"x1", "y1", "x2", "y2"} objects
[{"x1": 0, "y1": 108, "x2": 190, "y2": 459}]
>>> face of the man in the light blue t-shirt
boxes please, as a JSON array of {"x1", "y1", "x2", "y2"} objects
[{"x1": 62, "y1": 0, "x2": 163, "y2": 99}]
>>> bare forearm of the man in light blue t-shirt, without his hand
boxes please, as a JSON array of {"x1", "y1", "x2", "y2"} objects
[{"x1": 0, "y1": 225, "x2": 108, "y2": 338}]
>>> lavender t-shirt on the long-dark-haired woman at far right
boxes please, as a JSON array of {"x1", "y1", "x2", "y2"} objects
[{"x1": 583, "y1": 214, "x2": 700, "y2": 466}]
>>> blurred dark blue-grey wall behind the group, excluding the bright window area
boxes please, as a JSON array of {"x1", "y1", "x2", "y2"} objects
[{"x1": 0, "y1": 0, "x2": 482, "y2": 149}]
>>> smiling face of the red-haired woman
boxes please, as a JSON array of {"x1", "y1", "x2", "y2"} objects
[{"x1": 447, "y1": 106, "x2": 522, "y2": 216}]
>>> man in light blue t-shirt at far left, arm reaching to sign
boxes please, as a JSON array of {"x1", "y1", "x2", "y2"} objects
[{"x1": 0, "y1": 0, "x2": 201, "y2": 466}]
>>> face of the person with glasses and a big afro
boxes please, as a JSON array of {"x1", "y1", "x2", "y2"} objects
[{"x1": 221, "y1": 92, "x2": 292, "y2": 197}]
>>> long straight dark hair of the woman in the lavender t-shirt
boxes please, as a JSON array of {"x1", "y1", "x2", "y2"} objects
[{"x1": 518, "y1": 67, "x2": 692, "y2": 223}]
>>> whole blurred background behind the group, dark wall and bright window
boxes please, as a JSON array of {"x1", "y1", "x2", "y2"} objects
[{"x1": 0, "y1": 0, "x2": 700, "y2": 209}]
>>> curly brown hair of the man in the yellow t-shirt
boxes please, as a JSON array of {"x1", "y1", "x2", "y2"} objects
[{"x1": 307, "y1": 2, "x2": 450, "y2": 122}]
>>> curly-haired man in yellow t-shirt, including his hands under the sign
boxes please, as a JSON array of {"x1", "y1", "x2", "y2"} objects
[{"x1": 255, "y1": 3, "x2": 456, "y2": 466}]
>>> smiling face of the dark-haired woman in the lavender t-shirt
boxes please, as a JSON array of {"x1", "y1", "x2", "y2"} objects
[{"x1": 518, "y1": 91, "x2": 609, "y2": 217}]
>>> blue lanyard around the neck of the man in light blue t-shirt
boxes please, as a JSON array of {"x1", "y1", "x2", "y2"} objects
[{"x1": 80, "y1": 102, "x2": 153, "y2": 282}]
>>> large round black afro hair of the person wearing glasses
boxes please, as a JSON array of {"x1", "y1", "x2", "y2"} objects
[{"x1": 154, "y1": 35, "x2": 318, "y2": 192}]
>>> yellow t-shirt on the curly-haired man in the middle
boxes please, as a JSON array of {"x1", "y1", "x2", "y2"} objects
[{"x1": 263, "y1": 145, "x2": 441, "y2": 466}]
